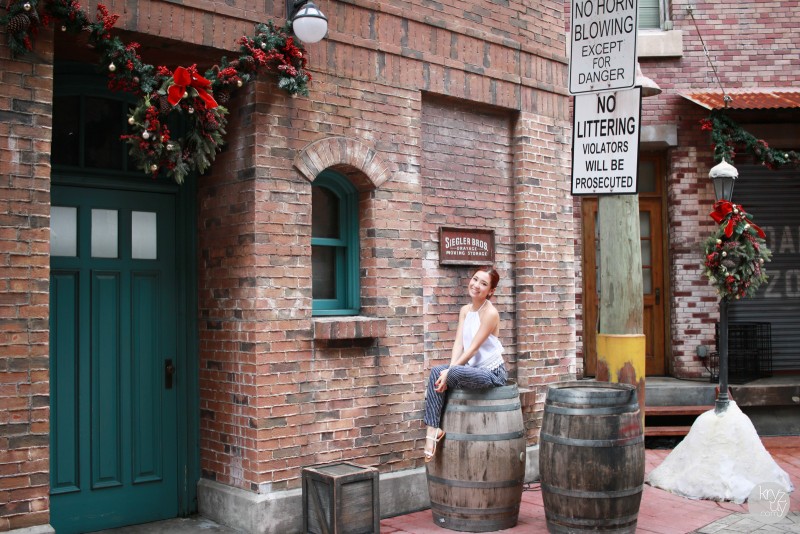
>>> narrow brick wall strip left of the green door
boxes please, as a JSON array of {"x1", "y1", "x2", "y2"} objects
[{"x1": 0, "y1": 28, "x2": 53, "y2": 531}]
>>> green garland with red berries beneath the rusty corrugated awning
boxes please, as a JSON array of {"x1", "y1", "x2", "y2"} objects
[{"x1": 700, "y1": 109, "x2": 800, "y2": 169}]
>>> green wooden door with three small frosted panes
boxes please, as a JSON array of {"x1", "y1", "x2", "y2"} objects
[{"x1": 50, "y1": 185, "x2": 180, "y2": 534}]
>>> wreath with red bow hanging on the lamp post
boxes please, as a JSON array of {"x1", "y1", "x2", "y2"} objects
[{"x1": 703, "y1": 200, "x2": 772, "y2": 299}]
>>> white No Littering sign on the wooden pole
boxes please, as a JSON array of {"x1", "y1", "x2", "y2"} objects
[{"x1": 572, "y1": 87, "x2": 642, "y2": 195}]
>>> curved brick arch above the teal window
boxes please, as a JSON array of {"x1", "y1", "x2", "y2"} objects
[{"x1": 293, "y1": 136, "x2": 390, "y2": 190}]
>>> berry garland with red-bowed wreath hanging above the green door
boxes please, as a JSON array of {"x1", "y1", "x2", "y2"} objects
[{"x1": 0, "y1": 0, "x2": 311, "y2": 183}]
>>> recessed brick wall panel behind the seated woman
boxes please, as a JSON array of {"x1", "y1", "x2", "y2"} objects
[{"x1": 420, "y1": 97, "x2": 516, "y2": 378}]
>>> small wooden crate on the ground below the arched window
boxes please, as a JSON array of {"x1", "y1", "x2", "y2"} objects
[{"x1": 303, "y1": 462, "x2": 381, "y2": 534}]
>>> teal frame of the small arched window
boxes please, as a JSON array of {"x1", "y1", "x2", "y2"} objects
[{"x1": 311, "y1": 170, "x2": 361, "y2": 316}]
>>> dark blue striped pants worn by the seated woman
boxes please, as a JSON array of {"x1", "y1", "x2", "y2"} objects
[{"x1": 423, "y1": 365, "x2": 508, "y2": 428}]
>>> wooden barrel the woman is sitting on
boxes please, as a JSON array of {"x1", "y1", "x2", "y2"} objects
[{"x1": 427, "y1": 384, "x2": 525, "y2": 532}]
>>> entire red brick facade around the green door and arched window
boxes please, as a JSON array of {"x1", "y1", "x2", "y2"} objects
[{"x1": 0, "y1": 0, "x2": 574, "y2": 529}]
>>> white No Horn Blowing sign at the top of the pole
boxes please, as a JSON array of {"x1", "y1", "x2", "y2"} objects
[{"x1": 569, "y1": 0, "x2": 638, "y2": 95}]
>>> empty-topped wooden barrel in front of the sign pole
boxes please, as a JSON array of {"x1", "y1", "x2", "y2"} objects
[{"x1": 539, "y1": 382, "x2": 644, "y2": 533}]
